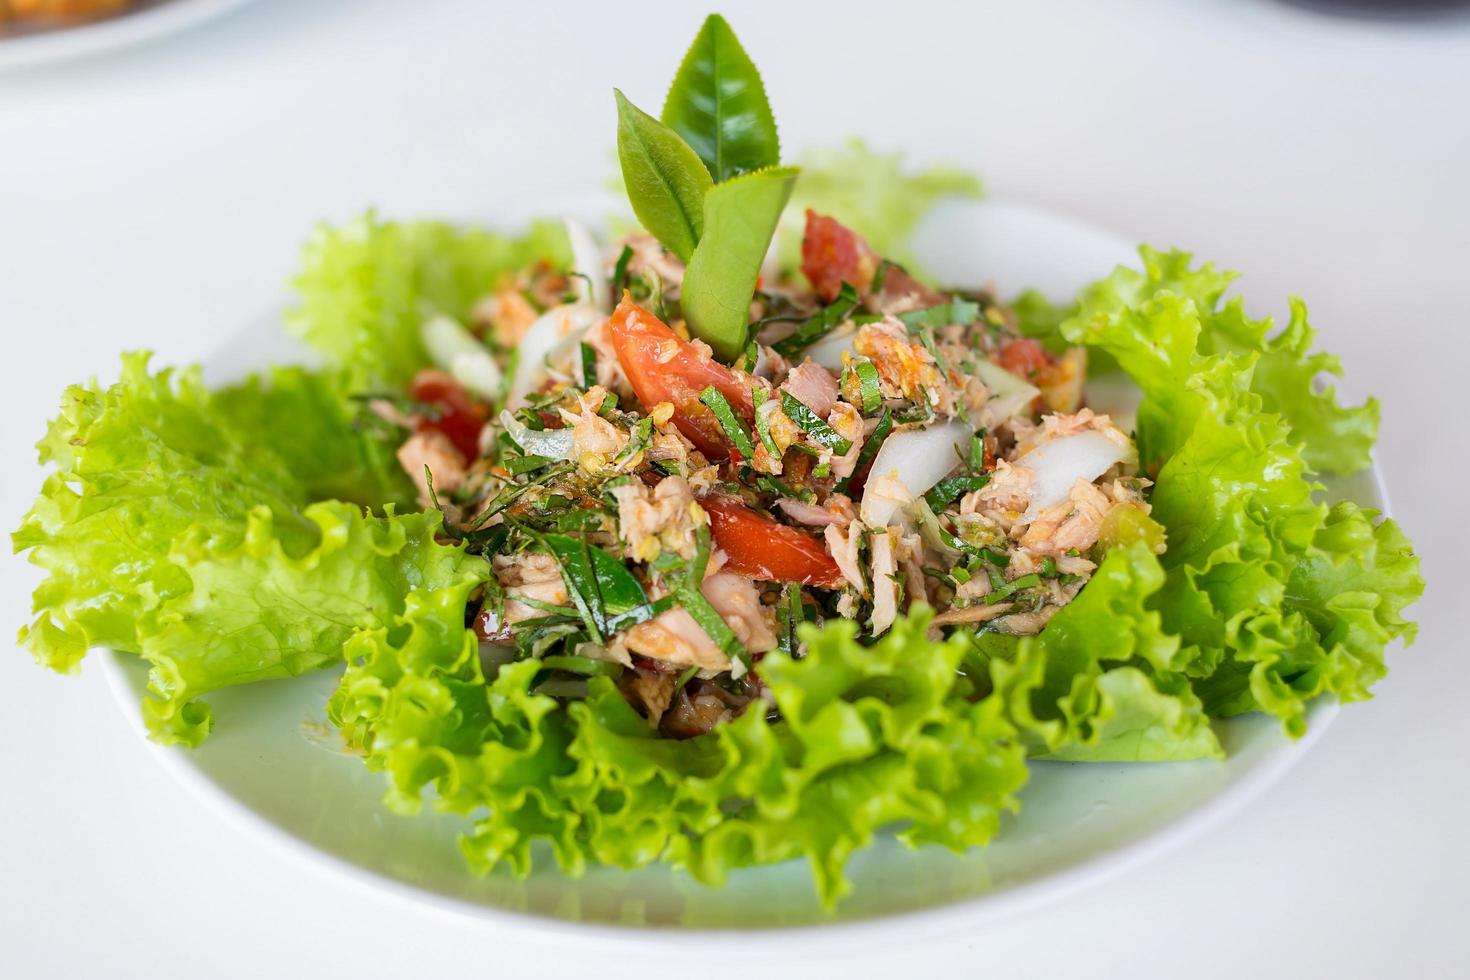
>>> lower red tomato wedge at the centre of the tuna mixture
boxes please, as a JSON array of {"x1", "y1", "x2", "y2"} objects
[{"x1": 700, "y1": 497, "x2": 844, "y2": 589}]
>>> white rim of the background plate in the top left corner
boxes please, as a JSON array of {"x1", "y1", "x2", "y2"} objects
[{"x1": 0, "y1": 0, "x2": 247, "y2": 71}]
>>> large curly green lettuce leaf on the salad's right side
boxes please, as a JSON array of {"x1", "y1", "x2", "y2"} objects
[{"x1": 1058, "y1": 248, "x2": 1423, "y2": 735}]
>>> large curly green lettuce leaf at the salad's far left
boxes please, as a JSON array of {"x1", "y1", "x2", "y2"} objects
[{"x1": 12, "y1": 354, "x2": 482, "y2": 745}]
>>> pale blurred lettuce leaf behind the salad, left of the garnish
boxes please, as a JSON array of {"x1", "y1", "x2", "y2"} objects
[{"x1": 287, "y1": 212, "x2": 569, "y2": 391}]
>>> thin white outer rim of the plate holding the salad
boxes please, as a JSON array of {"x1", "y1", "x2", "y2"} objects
[{"x1": 101, "y1": 195, "x2": 1375, "y2": 951}]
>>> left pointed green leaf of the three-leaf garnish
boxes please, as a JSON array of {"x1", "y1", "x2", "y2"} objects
[{"x1": 613, "y1": 88, "x2": 711, "y2": 262}]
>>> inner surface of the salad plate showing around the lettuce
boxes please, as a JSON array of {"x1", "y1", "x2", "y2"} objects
[{"x1": 97, "y1": 198, "x2": 1386, "y2": 949}]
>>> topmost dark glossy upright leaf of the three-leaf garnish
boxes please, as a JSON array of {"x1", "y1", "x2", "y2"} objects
[{"x1": 663, "y1": 13, "x2": 781, "y2": 182}]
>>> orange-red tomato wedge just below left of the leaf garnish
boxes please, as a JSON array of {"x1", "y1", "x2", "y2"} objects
[{"x1": 607, "y1": 294, "x2": 756, "y2": 460}]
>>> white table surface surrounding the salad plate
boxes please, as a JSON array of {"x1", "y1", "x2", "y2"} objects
[{"x1": 0, "y1": 0, "x2": 1470, "y2": 979}]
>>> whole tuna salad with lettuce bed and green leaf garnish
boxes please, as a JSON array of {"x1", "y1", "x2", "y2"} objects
[{"x1": 15, "y1": 16, "x2": 1423, "y2": 902}]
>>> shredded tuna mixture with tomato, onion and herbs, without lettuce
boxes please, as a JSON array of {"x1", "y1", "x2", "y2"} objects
[{"x1": 385, "y1": 210, "x2": 1150, "y2": 738}]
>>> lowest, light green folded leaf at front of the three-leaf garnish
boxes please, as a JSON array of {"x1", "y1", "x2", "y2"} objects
[{"x1": 684, "y1": 167, "x2": 797, "y2": 360}]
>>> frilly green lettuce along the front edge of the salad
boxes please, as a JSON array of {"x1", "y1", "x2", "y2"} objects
[{"x1": 329, "y1": 608, "x2": 1026, "y2": 904}]
